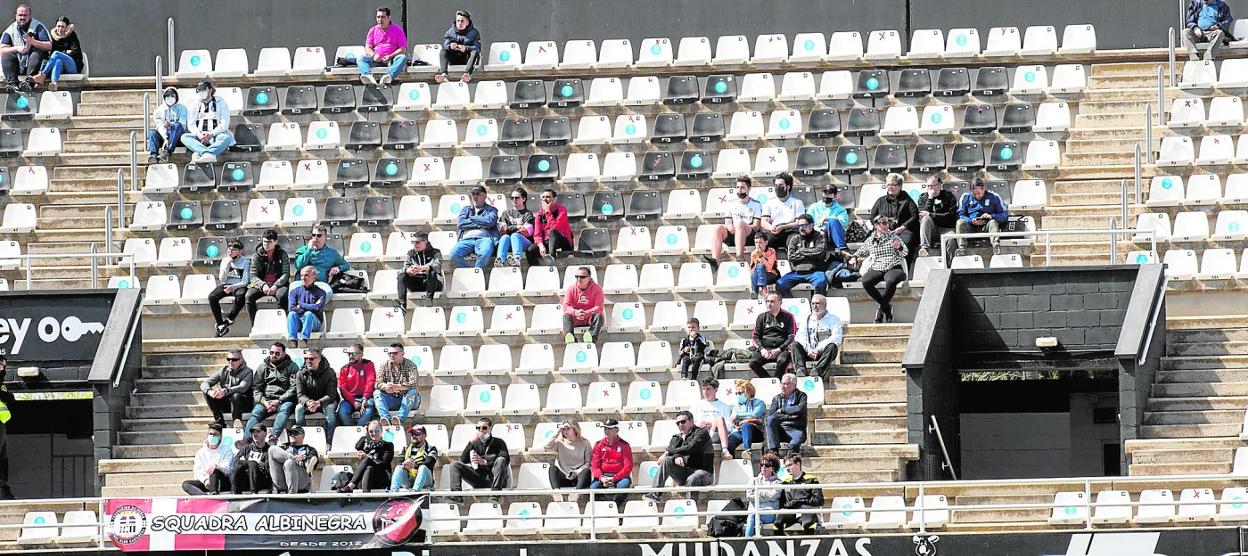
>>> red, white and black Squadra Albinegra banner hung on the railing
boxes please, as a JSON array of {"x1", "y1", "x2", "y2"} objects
[{"x1": 104, "y1": 495, "x2": 429, "y2": 552}]
